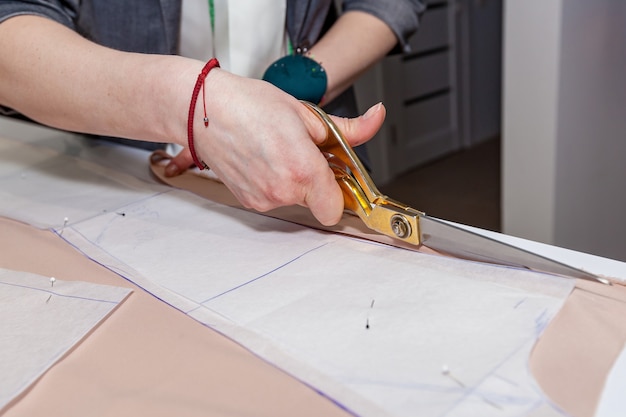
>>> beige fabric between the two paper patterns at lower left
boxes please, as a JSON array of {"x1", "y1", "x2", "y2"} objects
[{"x1": 0, "y1": 218, "x2": 348, "y2": 417}]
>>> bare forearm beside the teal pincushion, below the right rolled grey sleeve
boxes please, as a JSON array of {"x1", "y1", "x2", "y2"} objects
[{"x1": 311, "y1": 11, "x2": 397, "y2": 102}]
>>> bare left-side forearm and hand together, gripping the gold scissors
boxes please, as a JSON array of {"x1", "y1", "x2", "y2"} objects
[{"x1": 0, "y1": 16, "x2": 385, "y2": 225}]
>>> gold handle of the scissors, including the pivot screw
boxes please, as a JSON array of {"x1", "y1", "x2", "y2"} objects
[{"x1": 302, "y1": 101, "x2": 424, "y2": 245}]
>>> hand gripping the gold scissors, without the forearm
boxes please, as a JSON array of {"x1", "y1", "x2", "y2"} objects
[{"x1": 166, "y1": 70, "x2": 385, "y2": 225}]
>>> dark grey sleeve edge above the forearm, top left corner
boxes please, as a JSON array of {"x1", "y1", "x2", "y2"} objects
[{"x1": 0, "y1": 0, "x2": 79, "y2": 29}]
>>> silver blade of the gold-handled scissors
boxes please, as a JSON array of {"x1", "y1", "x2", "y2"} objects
[{"x1": 419, "y1": 215, "x2": 609, "y2": 284}]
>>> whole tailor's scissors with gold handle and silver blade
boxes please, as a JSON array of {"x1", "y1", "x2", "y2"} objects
[{"x1": 303, "y1": 101, "x2": 610, "y2": 285}]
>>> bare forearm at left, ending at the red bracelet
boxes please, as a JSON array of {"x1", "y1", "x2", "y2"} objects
[{"x1": 0, "y1": 16, "x2": 202, "y2": 142}]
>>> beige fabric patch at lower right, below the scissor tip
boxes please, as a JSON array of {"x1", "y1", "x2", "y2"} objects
[{"x1": 530, "y1": 281, "x2": 626, "y2": 417}]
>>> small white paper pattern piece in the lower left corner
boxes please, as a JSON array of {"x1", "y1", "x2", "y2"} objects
[{"x1": 0, "y1": 269, "x2": 131, "y2": 410}]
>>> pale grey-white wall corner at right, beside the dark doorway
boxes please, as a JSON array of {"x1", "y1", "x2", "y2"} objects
[{"x1": 502, "y1": 0, "x2": 626, "y2": 260}]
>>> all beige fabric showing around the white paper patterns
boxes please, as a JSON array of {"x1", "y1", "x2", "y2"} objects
[{"x1": 0, "y1": 149, "x2": 626, "y2": 416}]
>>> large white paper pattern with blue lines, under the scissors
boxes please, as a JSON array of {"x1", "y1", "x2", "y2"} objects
[{"x1": 0, "y1": 128, "x2": 616, "y2": 416}]
